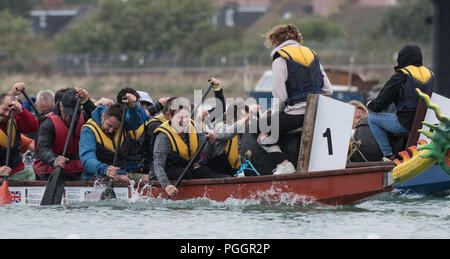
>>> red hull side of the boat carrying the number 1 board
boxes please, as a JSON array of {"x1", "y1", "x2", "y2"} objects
[{"x1": 138, "y1": 166, "x2": 392, "y2": 205}]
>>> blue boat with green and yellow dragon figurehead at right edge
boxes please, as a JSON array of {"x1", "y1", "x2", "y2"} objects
[{"x1": 393, "y1": 90, "x2": 450, "y2": 196}]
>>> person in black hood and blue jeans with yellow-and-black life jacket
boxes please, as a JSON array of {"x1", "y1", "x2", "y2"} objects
[{"x1": 367, "y1": 45, "x2": 435, "y2": 160}]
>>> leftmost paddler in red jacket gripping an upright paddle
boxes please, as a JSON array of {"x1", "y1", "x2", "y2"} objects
[{"x1": 0, "y1": 82, "x2": 38, "y2": 181}]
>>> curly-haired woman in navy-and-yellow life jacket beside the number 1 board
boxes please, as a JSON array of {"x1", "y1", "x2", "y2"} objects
[{"x1": 259, "y1": 24, "x2": 333, "y2": 174}]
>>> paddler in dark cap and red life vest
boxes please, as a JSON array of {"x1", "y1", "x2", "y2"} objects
[{"x1": 33, "y1": 89, "x2": 86, "y2": 181}]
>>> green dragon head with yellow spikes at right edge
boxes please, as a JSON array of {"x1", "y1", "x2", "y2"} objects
[{"x1": 416, "y1": 89, "x2": 450, "y2": 174}]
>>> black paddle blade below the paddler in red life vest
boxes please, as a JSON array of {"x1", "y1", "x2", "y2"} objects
[{"x1": 41, "y1": 167, "x2": 65, "y2": 205}]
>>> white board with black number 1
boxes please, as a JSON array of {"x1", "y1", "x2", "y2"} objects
[{"x1": 308, "y1": 96, "x2": 355, "y2": 172}]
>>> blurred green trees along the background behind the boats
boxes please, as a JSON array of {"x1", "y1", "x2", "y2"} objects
[{"x1": 0, "y1": 0, "x2": 431, "y2": 71}]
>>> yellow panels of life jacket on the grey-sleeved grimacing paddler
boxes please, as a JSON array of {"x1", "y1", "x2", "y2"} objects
[{"x1": 154, "y1": 120, "x2": 198, "y2": 161}]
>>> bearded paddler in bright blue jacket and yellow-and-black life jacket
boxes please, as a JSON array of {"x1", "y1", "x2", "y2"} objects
[{"x1": 79, "y1": 94, "x2": 144, "y2": 181}]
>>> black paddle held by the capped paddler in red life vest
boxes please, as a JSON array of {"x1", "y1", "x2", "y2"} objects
[{"x1": 41, "y1": 99, "x2": 80, "y2": 205}]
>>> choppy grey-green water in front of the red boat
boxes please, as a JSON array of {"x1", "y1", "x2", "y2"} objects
[{"x1": 0, "y1": 194, "x2": 450, "y2": 239}]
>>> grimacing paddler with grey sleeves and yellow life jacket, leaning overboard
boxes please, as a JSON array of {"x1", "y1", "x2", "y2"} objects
[{"x1": 150, "y1": 98, "x2": 228, "y2": 196}]
